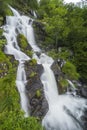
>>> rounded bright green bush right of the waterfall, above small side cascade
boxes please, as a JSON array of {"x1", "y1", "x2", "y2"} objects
[{"x1": 62, "y1": 61, "x2": 79, "y2": 80}]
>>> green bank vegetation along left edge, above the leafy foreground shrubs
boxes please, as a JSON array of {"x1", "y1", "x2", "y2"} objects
[{"x1": 0, "y1": 26, "x2": 19, "y2": 112}]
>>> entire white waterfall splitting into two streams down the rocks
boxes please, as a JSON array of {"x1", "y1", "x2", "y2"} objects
[{"x1": 4, "y1": 7, "x2": 87, "y2": 130}]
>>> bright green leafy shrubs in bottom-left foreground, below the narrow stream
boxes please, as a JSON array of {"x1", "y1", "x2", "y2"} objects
[{"x1": 0, "y1": 111, "x2": 43, "y2": 130}]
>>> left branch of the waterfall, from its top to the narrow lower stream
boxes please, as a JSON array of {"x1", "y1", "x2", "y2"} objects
[{"x1": 3, "y1": 7, "x2": 30, "y2": 117}]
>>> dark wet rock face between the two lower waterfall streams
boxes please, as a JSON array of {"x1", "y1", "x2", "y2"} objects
[{"x1": 25, "y1": 62, "x2": 48, "y2": 119}]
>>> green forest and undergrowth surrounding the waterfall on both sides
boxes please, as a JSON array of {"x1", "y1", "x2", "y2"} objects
[{"x1": 0, "y1": 0, "x2": 87, "y2": 130}]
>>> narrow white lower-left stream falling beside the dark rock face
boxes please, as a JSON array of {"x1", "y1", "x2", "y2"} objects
[{"x1": 16, "y1": 61, "x2": 30, "y2": 117}]
